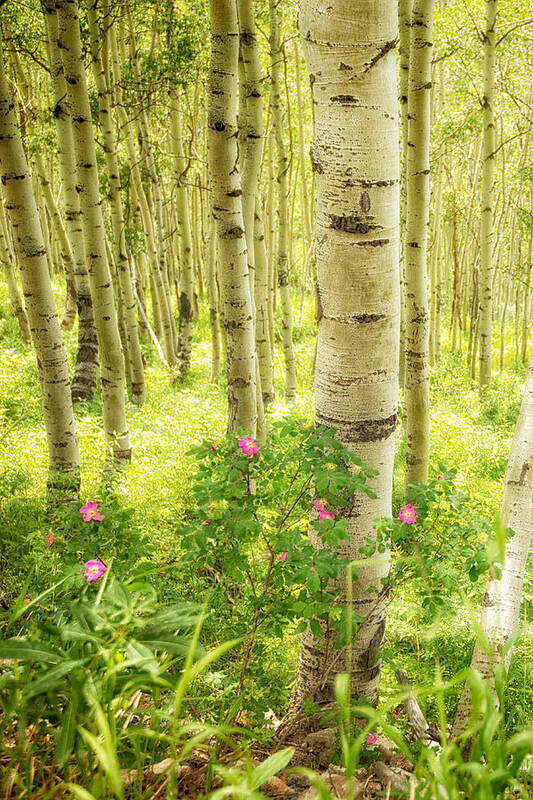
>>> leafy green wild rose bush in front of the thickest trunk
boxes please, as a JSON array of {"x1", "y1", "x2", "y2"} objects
[{"x1": 179, "y1": 419, "x2": 376, "y2": 708}]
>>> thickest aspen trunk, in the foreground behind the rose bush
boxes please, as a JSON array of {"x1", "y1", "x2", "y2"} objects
[{"x1": 293, "y1": 0, "x2": 400, "y2": 708}]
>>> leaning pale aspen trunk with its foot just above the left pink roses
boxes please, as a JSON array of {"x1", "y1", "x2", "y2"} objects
[{"x1": 57, "y1": 0, "x2": 131, "y2": 469}]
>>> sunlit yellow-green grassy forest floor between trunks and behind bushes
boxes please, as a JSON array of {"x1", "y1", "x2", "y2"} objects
[{"x1": 0, "y1": 282, "x2": 533, "y2": 792}]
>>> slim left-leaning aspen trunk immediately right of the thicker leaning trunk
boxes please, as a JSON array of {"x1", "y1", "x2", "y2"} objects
[{"x1": 87, "y1": 0, "x2": 144, "y2": 404}]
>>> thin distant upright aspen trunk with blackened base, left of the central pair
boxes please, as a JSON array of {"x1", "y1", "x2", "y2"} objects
[{"x1": 170, "y1": 89, "x2": 194, "y2": 372}]
